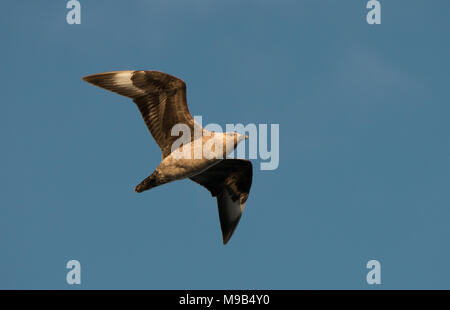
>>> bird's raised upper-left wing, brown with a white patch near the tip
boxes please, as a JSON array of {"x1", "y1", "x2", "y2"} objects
[{"x1": 83, "y1": 71, "x2": 202, "y2": 157}]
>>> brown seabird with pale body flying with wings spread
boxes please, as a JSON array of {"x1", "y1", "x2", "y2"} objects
[{"x1": 82, "y1": 70, "x2": 253, "y2": 245}]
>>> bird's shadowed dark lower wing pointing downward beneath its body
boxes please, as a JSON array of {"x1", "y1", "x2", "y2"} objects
[{"x1": 190, "y1": 159, "x2": 253, "y2": 244}]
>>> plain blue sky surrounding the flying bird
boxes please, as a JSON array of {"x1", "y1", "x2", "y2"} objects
[{"x1": 0, "y1": 0, "x2": 450, "y2": 289}]
